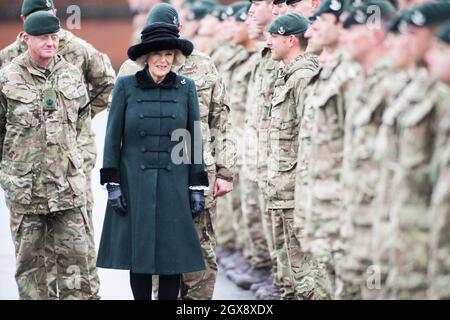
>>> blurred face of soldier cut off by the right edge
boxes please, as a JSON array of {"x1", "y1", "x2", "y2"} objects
[{"x1": 425, "y1": 41, "x2": 450, "y2": 85}]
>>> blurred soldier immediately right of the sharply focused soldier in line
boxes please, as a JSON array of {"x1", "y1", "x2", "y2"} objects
[{"x1": 296, "y1": 2, "x2": 361, "y2": 299}]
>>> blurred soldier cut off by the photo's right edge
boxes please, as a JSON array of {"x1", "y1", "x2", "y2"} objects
[{"x1": 426, "y1": 20, "x2": 450, "y2": 299}]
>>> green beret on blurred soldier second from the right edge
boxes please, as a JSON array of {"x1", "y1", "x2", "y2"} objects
[{"x1": 405, "y1": 1, "x2": 450, "y2": 27}]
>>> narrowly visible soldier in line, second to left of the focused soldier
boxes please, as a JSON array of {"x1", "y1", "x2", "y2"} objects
[{"x1": 221, "y1": 5, "x2": 271, "y2": 289}]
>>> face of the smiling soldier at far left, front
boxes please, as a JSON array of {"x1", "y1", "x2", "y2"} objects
[{"x1": 23, "y1": 33, "x2": 59, "y2": 61}]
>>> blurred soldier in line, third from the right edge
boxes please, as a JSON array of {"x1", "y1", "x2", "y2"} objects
[{"x1": 371, "y1": 12, "x2": 414, "y2": 299}]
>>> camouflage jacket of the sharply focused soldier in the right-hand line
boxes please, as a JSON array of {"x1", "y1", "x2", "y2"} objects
[{"x1": 267, "y1": 52, "x2": 319, "y2": 209}]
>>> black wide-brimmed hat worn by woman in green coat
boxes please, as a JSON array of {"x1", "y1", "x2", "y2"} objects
[{"x1": 128, "y1": 22, "x2": 194, "y2": 61}]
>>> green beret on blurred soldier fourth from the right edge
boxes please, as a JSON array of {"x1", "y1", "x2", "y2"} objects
[{"x1": 343, "y1": 0, "x2": 395, "y2": 29}]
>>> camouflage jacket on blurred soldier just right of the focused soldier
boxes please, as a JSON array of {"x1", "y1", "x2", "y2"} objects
[{"x1": 304, "y1": 52, "x2": 362, "y2": 250}]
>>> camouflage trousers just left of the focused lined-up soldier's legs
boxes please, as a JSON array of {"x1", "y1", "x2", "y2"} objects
[{"x1": 239, "y1": 171, "x2": 272, "y2": 269}]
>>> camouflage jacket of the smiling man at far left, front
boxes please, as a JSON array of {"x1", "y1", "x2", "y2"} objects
[{"x1": 0, "y1": 52, "x2": 91, "y2": 214}]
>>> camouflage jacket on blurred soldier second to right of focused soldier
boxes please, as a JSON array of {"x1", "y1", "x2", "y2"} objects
[{"x1": 342, "y1": 58, "x2": 398, "y2": 227}]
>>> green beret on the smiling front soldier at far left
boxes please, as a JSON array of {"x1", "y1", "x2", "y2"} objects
[{"x1": 23, "y1": 11, "x2": 61, "y2": 36}]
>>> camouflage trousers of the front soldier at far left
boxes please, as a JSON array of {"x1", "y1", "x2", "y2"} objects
[{"x1": 11, "y1": 207, "x2": 93, "y2": 300}]
